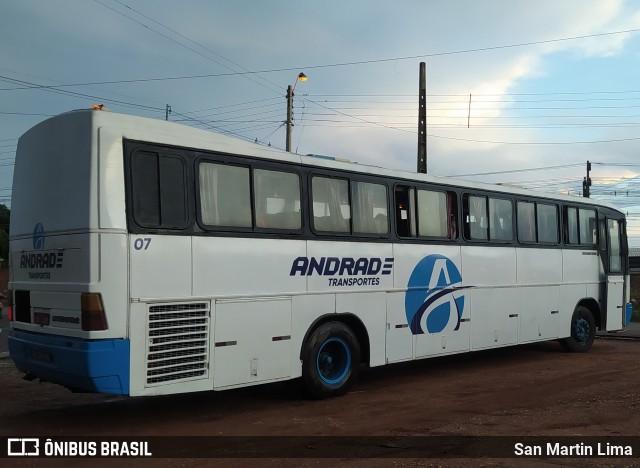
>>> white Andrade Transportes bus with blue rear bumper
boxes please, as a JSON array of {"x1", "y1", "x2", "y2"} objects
[{"x1": 9, "y1": 110, "x2": 630, "y2": 398}]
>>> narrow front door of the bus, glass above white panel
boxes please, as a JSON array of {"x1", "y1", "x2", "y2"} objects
[{"x1": 600, "y1": 218, "x2": 626, "y2": 330}]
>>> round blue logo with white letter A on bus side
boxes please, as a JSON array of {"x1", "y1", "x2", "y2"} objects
[{"x1": 405, "y1": 254, "x2": 464, "y2": 335}]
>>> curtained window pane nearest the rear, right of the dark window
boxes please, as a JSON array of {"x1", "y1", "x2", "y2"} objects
[{"x1": 199, "y1": 163, "x2": 251, "y2": 227}]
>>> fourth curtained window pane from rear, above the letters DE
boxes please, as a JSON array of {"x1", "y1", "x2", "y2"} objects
[{"x1": 351, "y1": 182, "x2": 389, "y2": 234}]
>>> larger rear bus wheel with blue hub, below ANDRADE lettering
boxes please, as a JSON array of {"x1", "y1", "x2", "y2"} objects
[{"x1": 302, "y1": 322, "x2": 360, "y2": 399}]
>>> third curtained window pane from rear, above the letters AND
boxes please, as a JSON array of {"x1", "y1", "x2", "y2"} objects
[{"x1": 311, "y1": 177, "x2": 351, "y2": 232}]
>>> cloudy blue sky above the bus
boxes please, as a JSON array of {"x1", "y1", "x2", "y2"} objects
[{"x1": 0, "y1": 0, "x2": 640, "y2": 246}]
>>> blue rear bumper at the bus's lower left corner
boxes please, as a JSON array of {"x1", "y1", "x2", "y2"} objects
[{"x1": 9, "y1": 330, "x2": 130, "y2": 395}]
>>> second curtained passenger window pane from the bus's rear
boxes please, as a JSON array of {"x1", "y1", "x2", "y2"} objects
[{"x1": 253, "y1": 169, "x2": 302, "y2": 230}]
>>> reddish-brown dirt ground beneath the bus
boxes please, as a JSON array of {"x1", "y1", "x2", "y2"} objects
[{"x1": 0, "y1": 339, "x2": 640, "y2": 467}]
